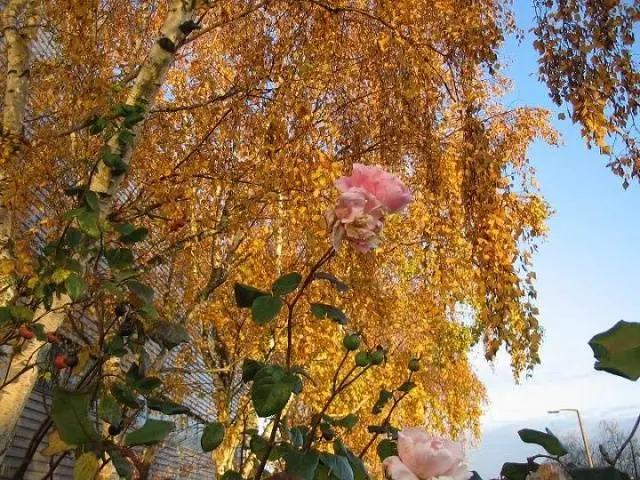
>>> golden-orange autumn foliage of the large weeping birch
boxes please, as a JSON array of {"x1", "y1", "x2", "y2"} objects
[{"x1": 1, "y1": 0, "x2": 556, "y2": 474}]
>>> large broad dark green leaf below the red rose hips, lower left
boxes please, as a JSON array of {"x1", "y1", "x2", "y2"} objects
[{"x1": 51, "y1": 389, "x2": 100, "y2": 445}]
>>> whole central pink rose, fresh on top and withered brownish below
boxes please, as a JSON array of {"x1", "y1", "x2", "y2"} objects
[{"x1": 325, "y1": 163, "x2": 412, "y2": 252}]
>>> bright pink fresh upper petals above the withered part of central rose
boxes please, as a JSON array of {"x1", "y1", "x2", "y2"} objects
[{"x1": 336, "y1": 163, "x2": 413, "y2": 213}]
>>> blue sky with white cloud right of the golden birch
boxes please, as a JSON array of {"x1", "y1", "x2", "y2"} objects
[{"x1": 470, "y1": 2, "x2": 640, "y2": 478}]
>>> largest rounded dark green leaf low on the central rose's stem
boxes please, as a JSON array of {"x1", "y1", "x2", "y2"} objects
[{"x1": 251, "y1": 366, "x2": 291, "y2": 417}]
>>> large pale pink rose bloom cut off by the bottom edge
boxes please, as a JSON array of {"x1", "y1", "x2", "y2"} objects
[{"x1": 385, "y1": 428, "x2": 471, "y2": 480}]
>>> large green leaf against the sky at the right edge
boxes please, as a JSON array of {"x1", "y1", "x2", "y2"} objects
[{"x1": 589, "y1": 320, "x2": 640, "y2": 381}]
